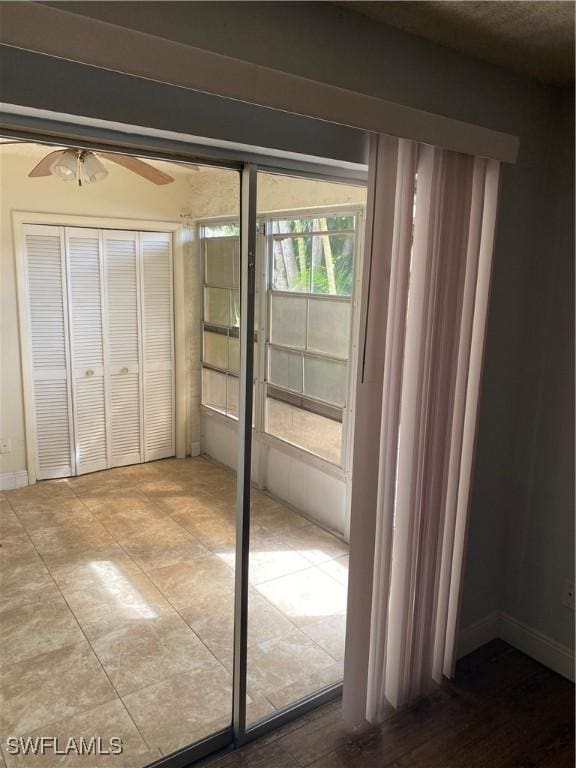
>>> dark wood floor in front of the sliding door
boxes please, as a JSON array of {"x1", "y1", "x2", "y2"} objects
[{"x1": 200, "y1": 640, "x2": 574, "y2": 768}]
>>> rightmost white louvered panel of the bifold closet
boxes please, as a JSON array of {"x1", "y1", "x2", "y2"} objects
[{"x1": 140, "y1": 232, "x2": 175, "y2": 461}]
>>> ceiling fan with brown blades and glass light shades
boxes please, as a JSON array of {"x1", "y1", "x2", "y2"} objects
[{"x1": 28, "y1": 149, "x2": 174, "y2": 186}]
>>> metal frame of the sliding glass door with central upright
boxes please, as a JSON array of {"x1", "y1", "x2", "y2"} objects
[{"x1": 0, "y1": 111, "x2": 366, "y2": 768}]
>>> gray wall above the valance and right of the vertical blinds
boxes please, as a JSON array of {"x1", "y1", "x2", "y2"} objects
[{"x1": 33, "y1": 2, "x2": 574, "y2": 642}]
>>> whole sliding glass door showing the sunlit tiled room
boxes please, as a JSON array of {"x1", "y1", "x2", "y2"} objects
[{"x1": 0, "y1": 118, "x2": 364, "y2": 768}]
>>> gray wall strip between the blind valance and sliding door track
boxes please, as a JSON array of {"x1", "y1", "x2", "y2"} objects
[{"x1": 0, "y1": 45, "x2": 368, "y2": 164}]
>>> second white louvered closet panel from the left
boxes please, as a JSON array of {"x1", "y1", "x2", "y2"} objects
[{"x1": 66, "y1": 227, "x2": 109, "y2": 475}]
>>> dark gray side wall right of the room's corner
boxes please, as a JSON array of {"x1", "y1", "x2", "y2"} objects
[{"x1": 501, "y1": 91, "x2": 574, "y2": 646}]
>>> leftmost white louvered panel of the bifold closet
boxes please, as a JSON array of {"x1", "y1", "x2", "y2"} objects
[{"x1": 24, "y1": 225, "x2": 75, "y2": 480}]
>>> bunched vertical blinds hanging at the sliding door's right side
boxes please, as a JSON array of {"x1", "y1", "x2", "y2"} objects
[{"x1": 345, "y1": 140, "x2": 499, "y2": 722}]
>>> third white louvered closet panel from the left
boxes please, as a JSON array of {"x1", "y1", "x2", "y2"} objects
[{"x1": 102, "y1": 230, "x2": 144, "y2": 467}]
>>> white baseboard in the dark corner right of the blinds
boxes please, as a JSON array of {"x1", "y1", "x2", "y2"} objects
[{"x1": 458, "y1": 611, "x2": 574, "y2": 682}]
